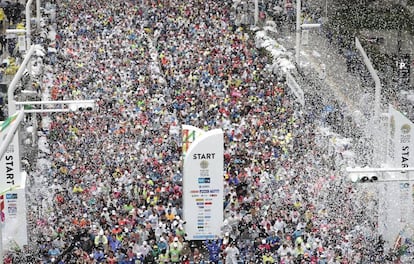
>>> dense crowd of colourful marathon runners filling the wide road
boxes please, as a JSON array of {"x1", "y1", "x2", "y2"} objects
[{"x1": 6, "y1": 0, "x2": 404, "y2": 264}]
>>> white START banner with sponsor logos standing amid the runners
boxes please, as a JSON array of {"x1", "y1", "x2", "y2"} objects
[{"x1": 183, "y1": 126, "x2": 224, "y2": 240}]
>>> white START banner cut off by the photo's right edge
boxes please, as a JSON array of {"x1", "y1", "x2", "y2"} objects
[{"x1": 378, "y1": 105, "x2": 414, "y2": 250}]
